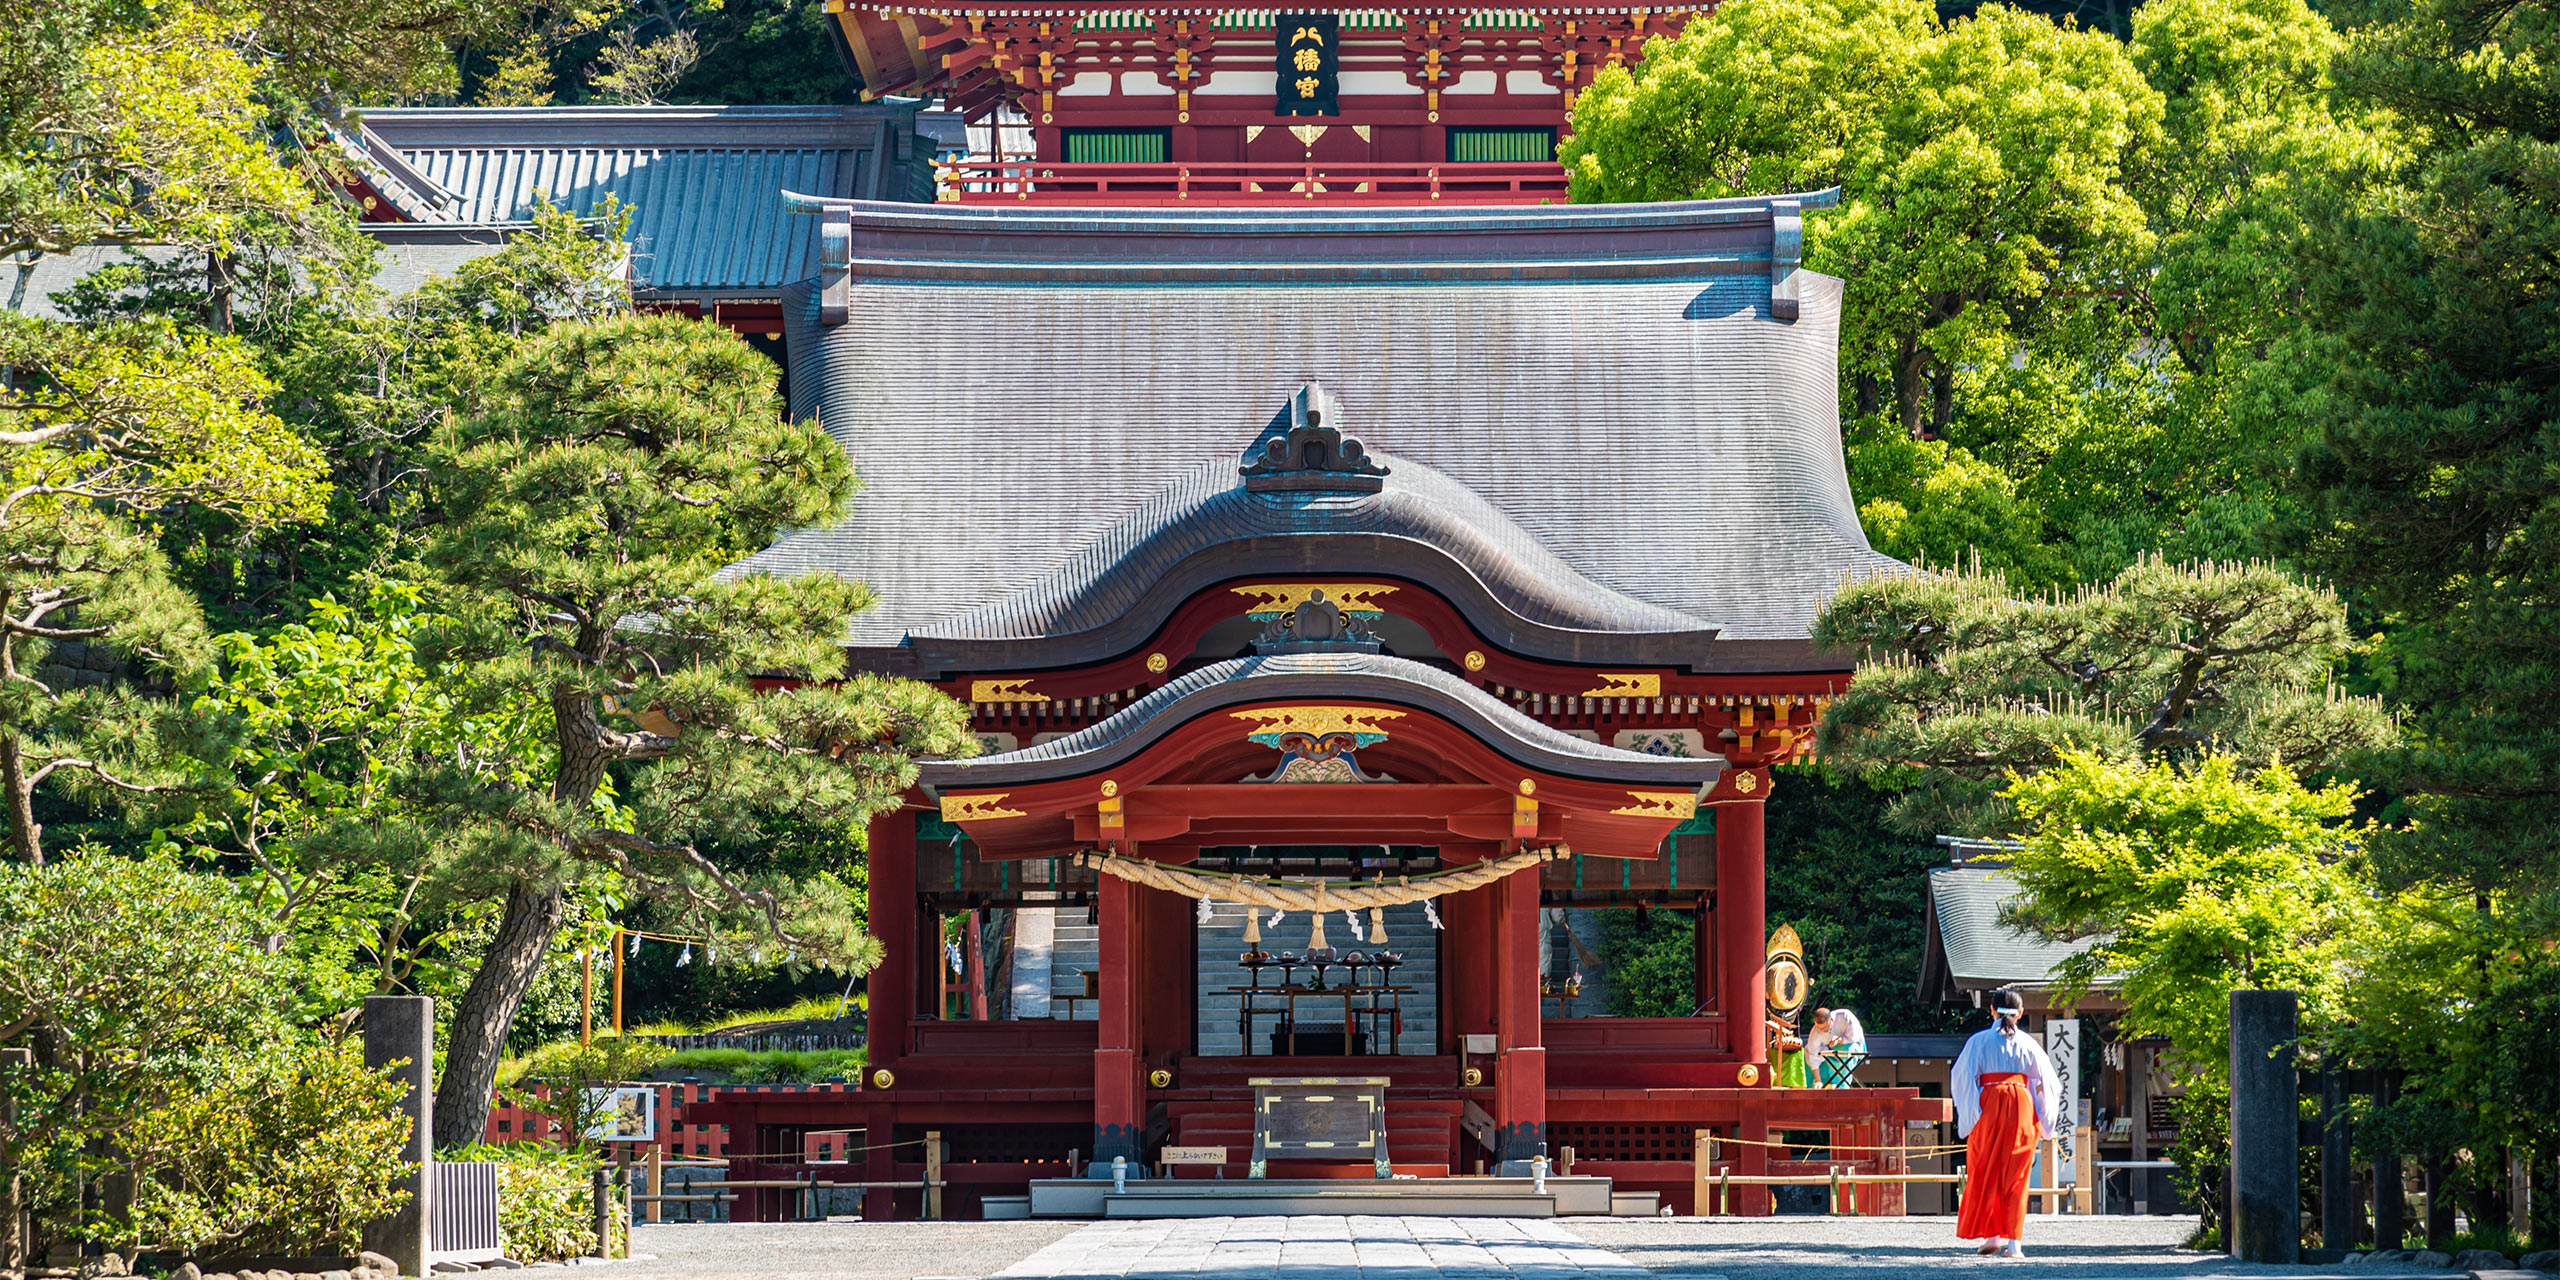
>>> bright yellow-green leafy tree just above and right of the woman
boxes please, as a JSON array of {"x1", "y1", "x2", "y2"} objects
[{"x1": 2010, "y1": 753, "x2": 2371, "y2": 1080}]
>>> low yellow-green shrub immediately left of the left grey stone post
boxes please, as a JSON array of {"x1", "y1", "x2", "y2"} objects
[{"x1": 125, "y1": 1044, "x2": 410, "y2": 1257}]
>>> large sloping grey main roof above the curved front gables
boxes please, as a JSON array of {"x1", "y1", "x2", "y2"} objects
[{"x1": 750, "y1": 205, "x2": 1894, "y2": 671}]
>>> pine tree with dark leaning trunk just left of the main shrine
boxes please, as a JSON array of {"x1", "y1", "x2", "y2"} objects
[{"x1": 409, "y1": 317, "x2": 973, "y2": 1144}]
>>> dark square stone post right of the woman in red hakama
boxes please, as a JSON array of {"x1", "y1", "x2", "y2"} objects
[{"x1": 2225, "y1": 991, "x2": 2301, "y2": 1265}]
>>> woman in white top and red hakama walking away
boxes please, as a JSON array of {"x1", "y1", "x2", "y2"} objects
[{"x1": 1948, "y1": 991, "x2": 2061, "y2": 1257}]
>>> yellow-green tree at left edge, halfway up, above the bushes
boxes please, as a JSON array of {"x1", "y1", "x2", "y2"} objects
[{"x1": 0, "y1": 317, "x2": 325, "y2": 863}]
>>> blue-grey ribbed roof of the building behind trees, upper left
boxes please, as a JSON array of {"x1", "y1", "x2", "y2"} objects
[{"x1": 364, "y1": 105, "x2": 932, "y2": 297}]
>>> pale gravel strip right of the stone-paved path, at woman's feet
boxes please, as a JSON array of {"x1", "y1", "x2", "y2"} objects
[{"x1": 1564, "y1": 1216, "x2": 2460, "y2": 1280}]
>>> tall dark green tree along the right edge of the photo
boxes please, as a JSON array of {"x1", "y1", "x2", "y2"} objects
[{"x1": 2268, "y1": 0, "x2": 2560, "y2": 1203}]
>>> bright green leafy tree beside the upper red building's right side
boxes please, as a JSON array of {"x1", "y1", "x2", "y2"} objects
[{"x1": 1562, "y1": 0, "x2": 2161, "y2": 448}]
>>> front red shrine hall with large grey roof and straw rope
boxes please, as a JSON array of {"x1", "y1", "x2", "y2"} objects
[{"x1": 686, "y1": 195, "x2": 1943, "y2": 1216}]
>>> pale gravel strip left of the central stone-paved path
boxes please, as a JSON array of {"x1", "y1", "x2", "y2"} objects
[{"x1": 627, "y1": 1221, "x2": 1085, "y2": 1280}]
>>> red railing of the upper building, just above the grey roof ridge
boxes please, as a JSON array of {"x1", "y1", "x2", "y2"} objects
[{"x1": 940, "y1": 161, "x2": 1567, "y2": 205}]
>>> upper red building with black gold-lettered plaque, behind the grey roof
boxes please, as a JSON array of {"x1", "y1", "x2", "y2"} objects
[{"x1": 827, "y1": 0, "x2": 1700, "y2": 205}]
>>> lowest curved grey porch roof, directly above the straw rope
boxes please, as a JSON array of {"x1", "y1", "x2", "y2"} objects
[{"x1": 919, "y1": 653, "x2": 1725, "y2": 788}]
